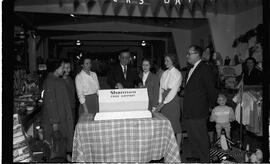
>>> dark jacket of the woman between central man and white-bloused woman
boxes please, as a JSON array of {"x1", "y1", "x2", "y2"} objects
[{"x1": 144, "y1": 72, "x2": 159, "y2": 110}]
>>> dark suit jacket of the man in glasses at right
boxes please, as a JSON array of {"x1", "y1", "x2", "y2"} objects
[{"x1": 183, "y1": 61, "x2": 217, "y2": 119}]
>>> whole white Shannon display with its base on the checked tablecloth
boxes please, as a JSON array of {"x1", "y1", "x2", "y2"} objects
[{"x1": 94, "y1": 88, "x2": 152, "y2": 120}]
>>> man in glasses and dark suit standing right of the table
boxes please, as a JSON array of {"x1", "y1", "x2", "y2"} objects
[{"x1": 183, "y1": 45, "x2": 217, "y2": 162}]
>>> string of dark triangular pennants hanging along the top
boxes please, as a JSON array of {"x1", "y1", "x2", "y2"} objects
[{"x1": 65, "y1": 0, "x2": 218, "y2": 17}]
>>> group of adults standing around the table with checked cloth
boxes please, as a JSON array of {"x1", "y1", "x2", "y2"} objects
[{"x1": 44, "y1": 45, "x2": 217, "y2": 162}]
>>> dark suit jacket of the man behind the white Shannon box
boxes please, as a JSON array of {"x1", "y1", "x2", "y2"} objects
[{"x1": 107, "y1": 64, "x2": 141, "y2": 89}]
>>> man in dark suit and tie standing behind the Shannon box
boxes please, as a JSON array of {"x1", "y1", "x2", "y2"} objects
[{"x1": 107, "y1": 50, "x2": 141, "y2": 89}]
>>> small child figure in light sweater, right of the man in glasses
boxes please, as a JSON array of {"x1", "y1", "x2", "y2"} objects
[{"x1": 210, "y1": 94, "x2": 235, "y2": 139}]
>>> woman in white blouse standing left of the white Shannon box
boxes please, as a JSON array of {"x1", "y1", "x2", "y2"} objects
[{"x1": 75, "y1": 56, "x2": 100, "y2": 115}]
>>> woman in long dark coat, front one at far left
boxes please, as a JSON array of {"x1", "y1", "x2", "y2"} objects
[{"x1": 42, "y1": 60, "x2": 74, "y2": 160}]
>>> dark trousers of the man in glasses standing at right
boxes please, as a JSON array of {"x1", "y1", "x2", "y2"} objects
[{"x1": 184, "y1": 118, "x2": 210, "y2": 162}]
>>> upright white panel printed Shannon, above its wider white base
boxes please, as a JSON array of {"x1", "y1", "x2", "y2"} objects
[{"x1": 98, "y1": 88, "x2": 148, "y2": 112}]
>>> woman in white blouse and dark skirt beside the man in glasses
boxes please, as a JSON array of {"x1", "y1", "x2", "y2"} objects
[{"x1": 155, "y1": 54, "x2": 182, "y2": 150}]
